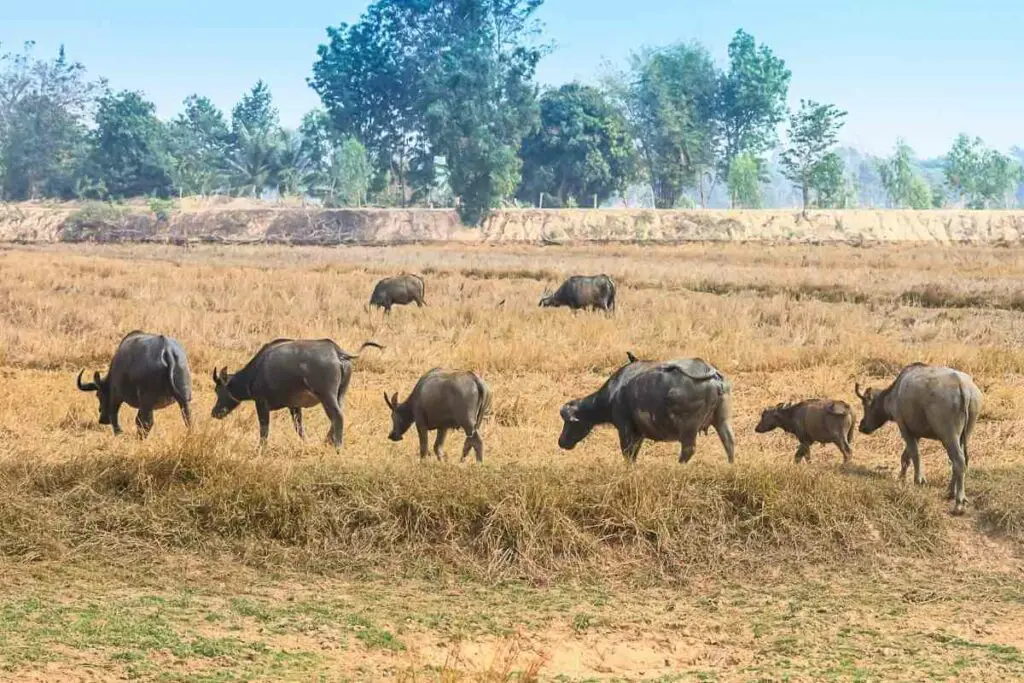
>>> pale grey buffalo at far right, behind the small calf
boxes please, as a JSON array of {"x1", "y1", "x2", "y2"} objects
[{"x1": 854, "y1": 362, "x2": 981, "y2": 514}]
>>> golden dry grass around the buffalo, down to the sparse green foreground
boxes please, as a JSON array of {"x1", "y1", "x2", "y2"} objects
[{"x1": 0, "y1": 240, "x2": 1024, "y2": 680}]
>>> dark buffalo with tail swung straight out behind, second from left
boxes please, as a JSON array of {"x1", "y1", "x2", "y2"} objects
[{"x1": 213, "y1": 339, "x2": 384, "y2": 449}]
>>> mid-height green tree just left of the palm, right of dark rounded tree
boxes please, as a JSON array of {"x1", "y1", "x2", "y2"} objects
[{"x1": 168, "y1": 95, "x2": 230, "y2": 195}]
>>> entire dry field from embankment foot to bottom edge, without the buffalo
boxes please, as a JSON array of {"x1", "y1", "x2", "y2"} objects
[{"x1": 0, "y1": 245, "x2": 1024, "y2": 681}]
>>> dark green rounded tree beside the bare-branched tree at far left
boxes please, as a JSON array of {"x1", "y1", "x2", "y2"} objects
[{"x1": 89, "y1": 90, "x2": 172, "y2": 197}]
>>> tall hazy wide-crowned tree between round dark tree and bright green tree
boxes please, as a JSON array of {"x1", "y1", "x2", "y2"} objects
[{"x1": 613, "y1": 43, "x2": 720, "y2": 208}]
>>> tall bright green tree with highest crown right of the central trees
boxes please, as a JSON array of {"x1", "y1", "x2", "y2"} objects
[{"x1": 718, "y1": 30, "x2": 792, "y2": 187}]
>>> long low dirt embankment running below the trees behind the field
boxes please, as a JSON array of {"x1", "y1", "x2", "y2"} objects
[{"x1": 0, "y1": 202, "x2": 1024, "y2": 244}]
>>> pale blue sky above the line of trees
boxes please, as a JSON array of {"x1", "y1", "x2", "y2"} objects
[{"x1": 0, "y1": 0, "x2": 1024, "y2": 156}]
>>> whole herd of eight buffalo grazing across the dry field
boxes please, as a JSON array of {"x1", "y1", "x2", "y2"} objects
[{"x1": 78, "y1": 274, "x2": 981, "y2": 513}]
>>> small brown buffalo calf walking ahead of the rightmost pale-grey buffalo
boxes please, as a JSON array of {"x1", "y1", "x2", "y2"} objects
[{"x1": 754, "y1": 398, "x2": 854, "y2": 463}]
